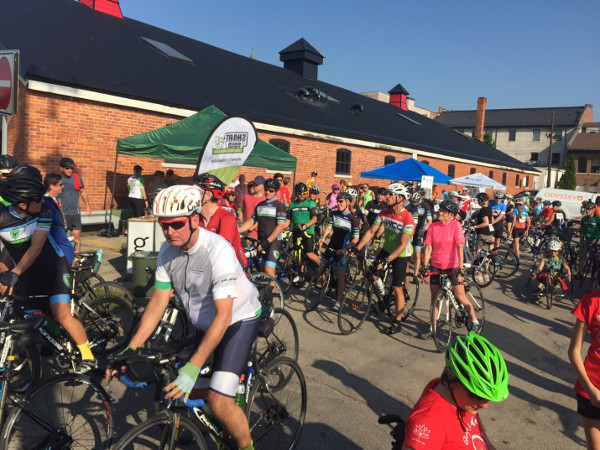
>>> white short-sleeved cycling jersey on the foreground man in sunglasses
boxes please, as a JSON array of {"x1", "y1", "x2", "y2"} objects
[{"x1": 155, "y1": 228, "x2": 261, "y2": 331}]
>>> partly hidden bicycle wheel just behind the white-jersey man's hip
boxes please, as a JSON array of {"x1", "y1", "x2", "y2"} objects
[{"x1": 254, "y1": 308, "x2": 300, "y2": 367}]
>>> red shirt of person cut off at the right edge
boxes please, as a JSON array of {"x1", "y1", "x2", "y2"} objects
[{"x1": 571, "y1": 290, "x2": 600, "y2": 398}]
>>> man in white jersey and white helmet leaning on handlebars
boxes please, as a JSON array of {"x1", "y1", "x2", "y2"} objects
[{"x1": 126, "y1": 185, "x2": 261, "y2": 449}]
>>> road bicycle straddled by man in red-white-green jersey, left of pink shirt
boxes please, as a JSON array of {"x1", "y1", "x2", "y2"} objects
[{"x1": 338, "y1": 255, "x2": 419, "y2": 334}]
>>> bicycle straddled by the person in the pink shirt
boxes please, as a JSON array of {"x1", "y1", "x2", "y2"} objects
[{"x1": 423, "y1": 272, "x2": 485, "y2": 352}]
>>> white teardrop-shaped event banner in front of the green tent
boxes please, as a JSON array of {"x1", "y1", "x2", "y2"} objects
[{"x1": 196, "y1": 117, "x2": 257, "y2": 185}]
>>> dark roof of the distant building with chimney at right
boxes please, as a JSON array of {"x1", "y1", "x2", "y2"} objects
[{"x1": 435, "y1": 106, "x2": 585, "y2": 128}]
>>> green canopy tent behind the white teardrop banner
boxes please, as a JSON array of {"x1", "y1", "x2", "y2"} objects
[{"x1": 106, "y1": 106, "x2": 296, "y2": 232}]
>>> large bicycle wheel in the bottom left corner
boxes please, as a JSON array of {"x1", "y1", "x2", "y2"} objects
[{"x1": 2, "y1": 373, "x2": 112, "y2": 449}]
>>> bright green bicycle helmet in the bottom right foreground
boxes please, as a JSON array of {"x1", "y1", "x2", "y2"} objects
[{"x1": 446, "y1": 331, "x2": 508, "y2": 402}]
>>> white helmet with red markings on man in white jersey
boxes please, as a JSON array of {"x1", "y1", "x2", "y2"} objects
[{"x1": 152, "y1": 185, "x2": 204, "y2": 217}]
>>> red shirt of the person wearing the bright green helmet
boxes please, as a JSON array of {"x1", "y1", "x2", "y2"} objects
[{"x1": 403, "y1": 378, "x2": 489, "y2": 449}]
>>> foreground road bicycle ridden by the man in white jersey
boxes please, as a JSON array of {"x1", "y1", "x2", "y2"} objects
[{"x1": 113, "y1": 342, "x2": 307, "y2": 450}]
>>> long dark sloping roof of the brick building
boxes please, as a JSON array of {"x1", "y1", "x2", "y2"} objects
[{"x1": 0, "y1": 0, "x2": 530, "y2": 170}]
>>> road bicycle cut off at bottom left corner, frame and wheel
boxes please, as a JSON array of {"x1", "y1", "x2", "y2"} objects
[{"x1": 0, "y1": 315, "x2": 113, "y2": 450}]
